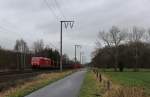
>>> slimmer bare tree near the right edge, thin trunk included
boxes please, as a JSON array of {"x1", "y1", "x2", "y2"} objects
[{"x1": 128, "y1": 26, "x2": 145, "y2": 71}]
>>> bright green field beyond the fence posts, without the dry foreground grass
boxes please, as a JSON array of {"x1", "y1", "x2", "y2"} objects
[{"x1": 104, "y1": 72, "x2": 150, "y2": 94}]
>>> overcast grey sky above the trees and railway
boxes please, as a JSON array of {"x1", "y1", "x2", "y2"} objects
[{"x1": 0, "y1": 0, "x2": 150, "y2": 61}]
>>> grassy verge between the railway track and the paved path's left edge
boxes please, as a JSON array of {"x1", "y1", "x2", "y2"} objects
[{"x1": 0, "y1": 71, "x2": 72, "y2": 97}]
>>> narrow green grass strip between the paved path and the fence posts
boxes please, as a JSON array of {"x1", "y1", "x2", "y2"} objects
[{"x1": 79, "y1": 71, "x2": 101, "y2": 97}]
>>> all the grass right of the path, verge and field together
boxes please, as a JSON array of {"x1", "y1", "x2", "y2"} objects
[{"x1": 79, "y1": 70, "x2": 150, "y2": 97}]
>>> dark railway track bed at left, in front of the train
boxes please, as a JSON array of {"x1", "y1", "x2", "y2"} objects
[{"x1": 0, "y1": 70, "x2": 57, "y2": 92}]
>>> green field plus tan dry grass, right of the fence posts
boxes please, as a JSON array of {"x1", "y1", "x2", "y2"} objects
[{"x1": 101, "y1": 70, "x2": 150, "y2": 97}]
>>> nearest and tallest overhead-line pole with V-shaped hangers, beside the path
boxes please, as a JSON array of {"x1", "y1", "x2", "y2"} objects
[{"x1": 60, "y1": 21, "x2": 74, "y2": 71}]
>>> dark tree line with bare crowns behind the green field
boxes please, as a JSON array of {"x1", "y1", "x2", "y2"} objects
[{"x1": 92, "y1": 26, "x2": 150, "y2": 71}]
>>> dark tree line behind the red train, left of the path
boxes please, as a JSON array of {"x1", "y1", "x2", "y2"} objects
[{"x1": 0, "y1": 39, "x2": 73, "y2": 70}]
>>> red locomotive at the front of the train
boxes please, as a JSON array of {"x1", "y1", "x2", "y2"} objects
[{"x1": 31, "y1": 57, "x2": 56, "y2": 69}]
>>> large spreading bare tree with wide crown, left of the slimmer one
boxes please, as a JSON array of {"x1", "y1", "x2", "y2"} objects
[{"x1": 99, "y1": 26, "x2": 126, "y2": 71}]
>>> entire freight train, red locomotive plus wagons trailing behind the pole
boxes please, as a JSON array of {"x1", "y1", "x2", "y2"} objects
[{"x1": 31, "y1": 57, "x2": 82, "y2": 69}]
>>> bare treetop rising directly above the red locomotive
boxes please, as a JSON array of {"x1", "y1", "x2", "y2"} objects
[{"x1": 33, "y1": 40, "x2": 44, "y2": 53}]
